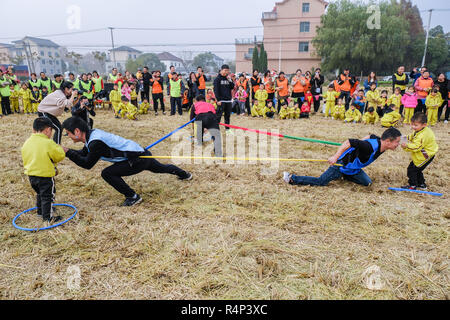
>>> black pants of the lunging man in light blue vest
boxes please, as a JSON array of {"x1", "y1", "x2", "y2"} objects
[{"x1": 102, "y1": 151, "x2": 188, "y2": 198}]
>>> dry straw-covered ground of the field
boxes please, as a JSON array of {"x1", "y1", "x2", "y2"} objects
[{"x1": 0, "y1": 111, "x2": 450, "y2": 299}]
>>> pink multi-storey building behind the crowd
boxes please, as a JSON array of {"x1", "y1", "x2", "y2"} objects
[{"x1": 235, "y1": 0, "x2": 328, "y2": 73}]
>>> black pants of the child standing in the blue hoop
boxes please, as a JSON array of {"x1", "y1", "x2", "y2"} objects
[{"x1": 29, "y1": 176, "x2": 56, "y2": 220}]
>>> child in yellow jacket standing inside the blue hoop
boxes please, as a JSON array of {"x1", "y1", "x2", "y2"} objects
[{"x1": 21, "y1": 117, "x2": 66, "y2": 223}]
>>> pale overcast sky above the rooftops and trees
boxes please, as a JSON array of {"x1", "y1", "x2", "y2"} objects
[{"x1": 0, "y1": 0, "x2": 450, "y2": 59}]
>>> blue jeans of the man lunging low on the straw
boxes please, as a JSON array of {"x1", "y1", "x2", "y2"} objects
[{"x1": 291, "y1": 166, "x2": 372, "y2": 187}]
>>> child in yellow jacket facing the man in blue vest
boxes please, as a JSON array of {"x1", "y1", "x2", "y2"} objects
[{"x1": 401, "y1": 112, "x2": 439, "y2": 190}]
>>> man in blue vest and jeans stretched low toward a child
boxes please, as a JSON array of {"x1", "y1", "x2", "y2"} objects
[{"x1": 283, "y1": 128, "x2": 402, "y2": 187}]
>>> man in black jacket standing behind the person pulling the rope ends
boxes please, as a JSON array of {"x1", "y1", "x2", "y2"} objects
[{"x1": 214, "y1": 64, "x2": 234, "y2": 132}]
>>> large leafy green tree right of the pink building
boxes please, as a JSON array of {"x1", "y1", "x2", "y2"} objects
[{"x1": 313, "y1": 0, "x2": 417, "y2": 74}]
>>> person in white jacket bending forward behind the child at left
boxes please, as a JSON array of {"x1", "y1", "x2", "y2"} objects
[{"x1": 38, "y1": 81, "x2": 78, "y2": 144}]
